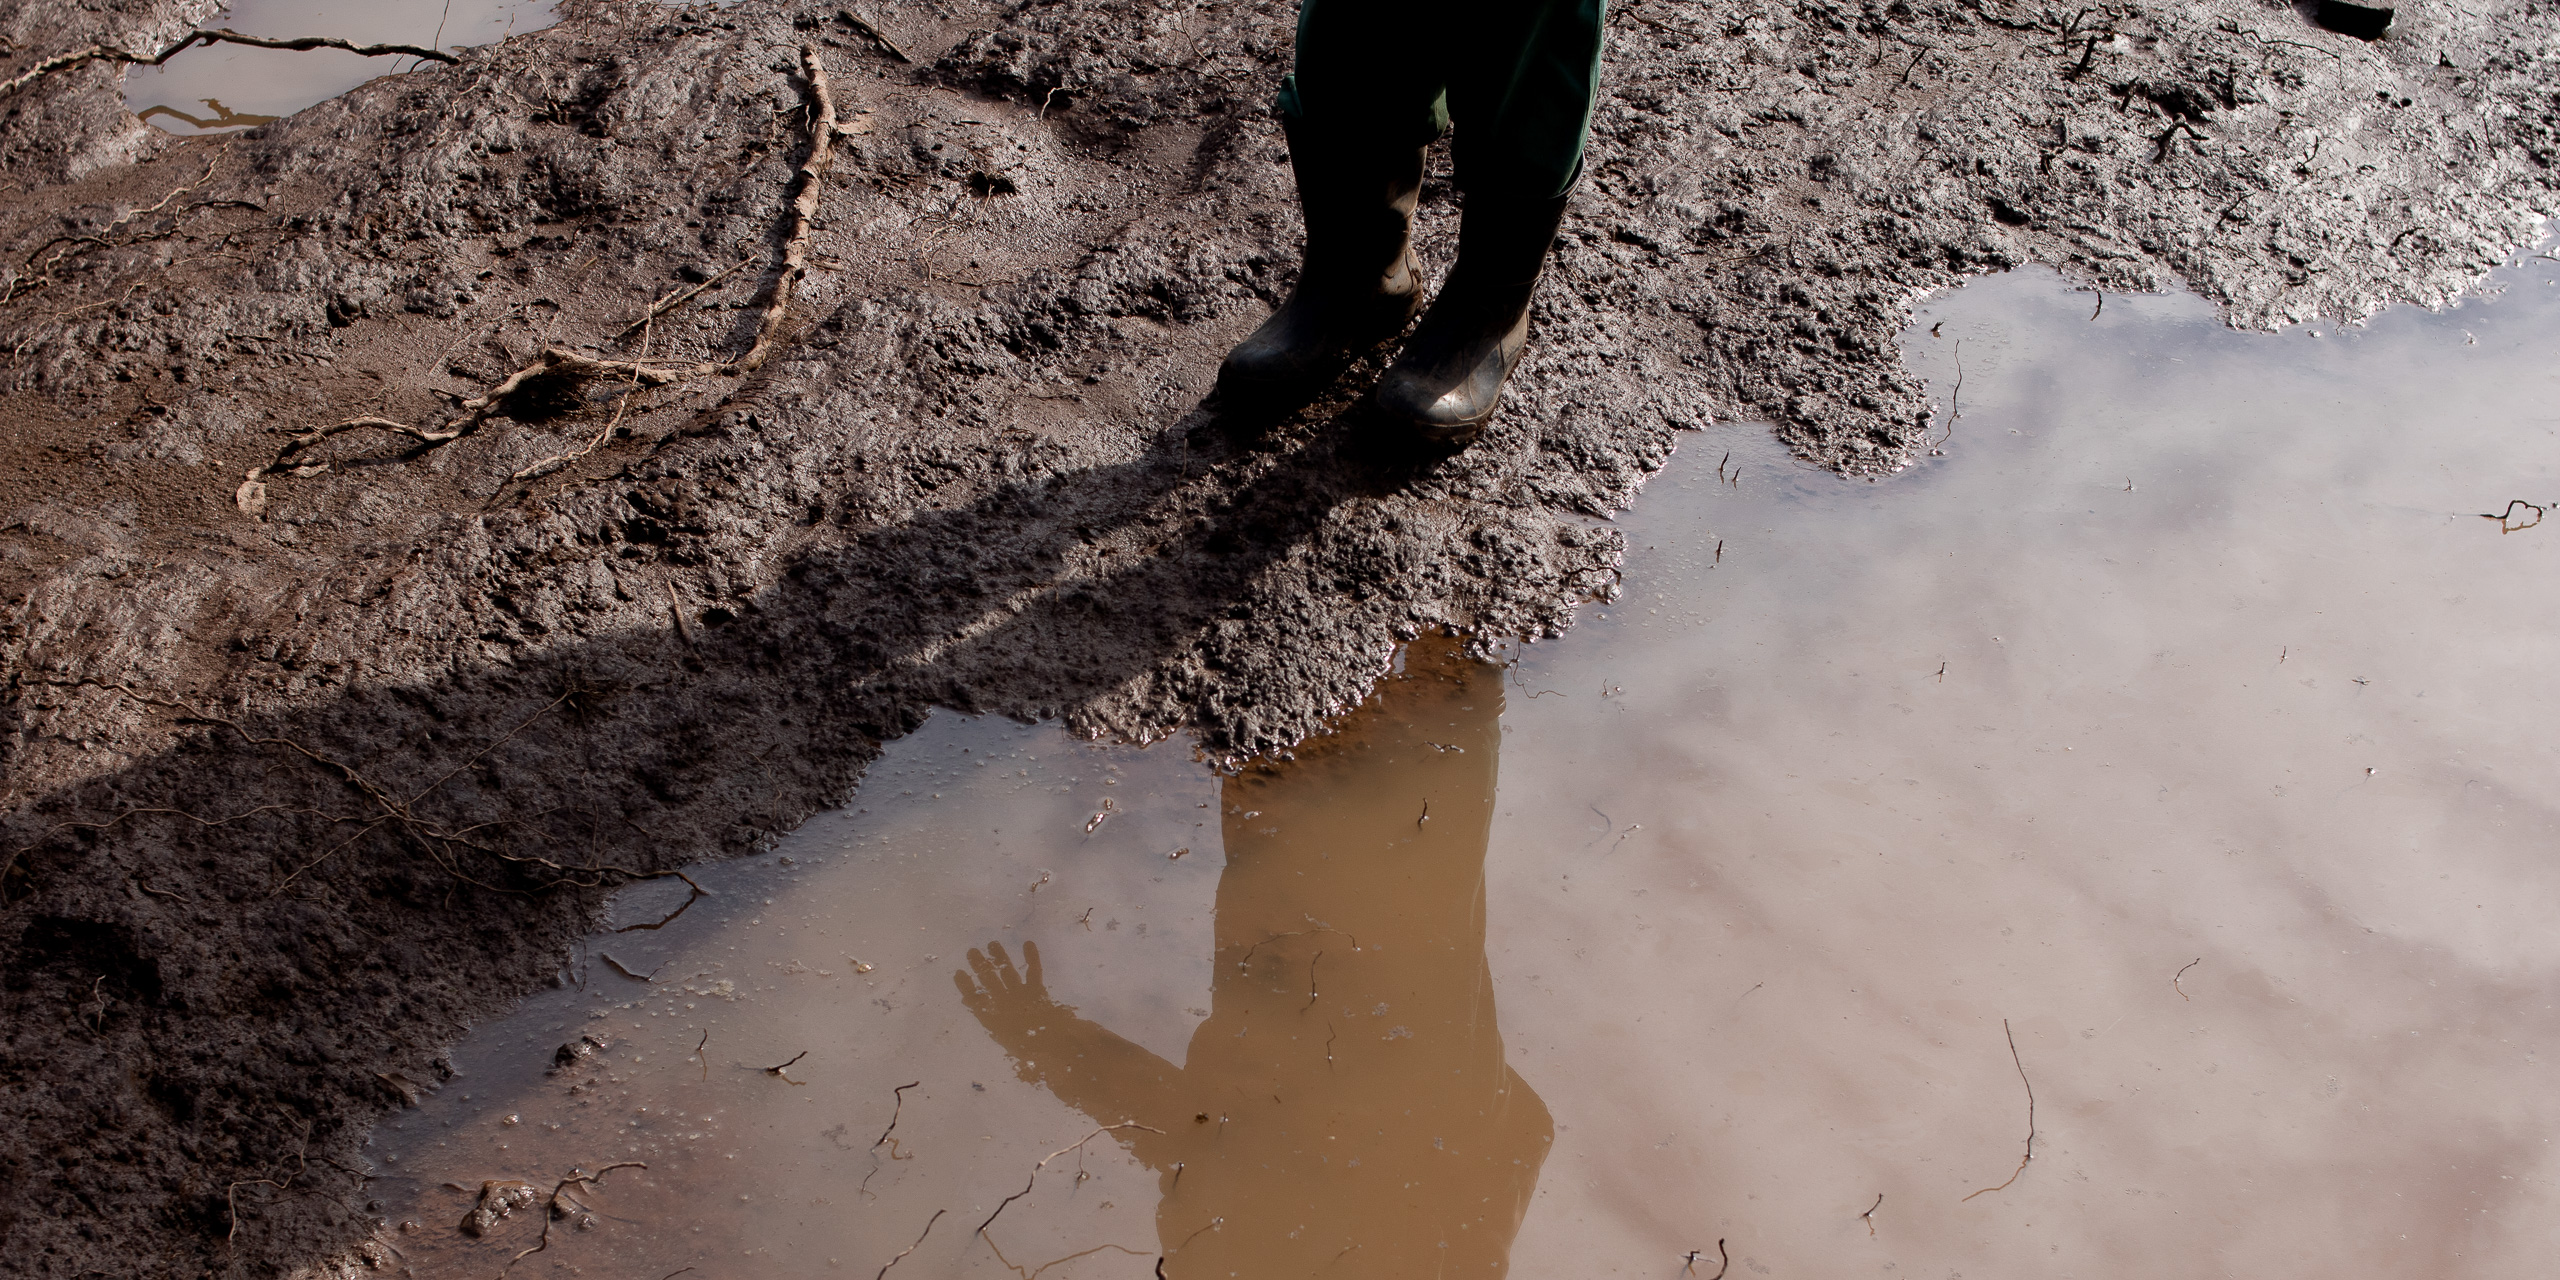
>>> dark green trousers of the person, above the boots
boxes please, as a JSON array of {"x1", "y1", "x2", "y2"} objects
[{"x1": 1280, "y1": 0, "x2": 1605, "y2": 200}]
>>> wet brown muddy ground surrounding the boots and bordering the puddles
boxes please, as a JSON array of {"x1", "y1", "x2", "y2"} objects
[{"x1": 0, "y1": 0, "x2": 2560, "y2": 1277}]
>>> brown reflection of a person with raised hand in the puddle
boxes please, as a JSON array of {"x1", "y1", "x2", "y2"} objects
[{"x1": 955, "y1": 640, "x2": 1554, "y2": 1280}]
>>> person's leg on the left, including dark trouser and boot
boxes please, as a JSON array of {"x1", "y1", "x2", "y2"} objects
[{"x1": 1219, "y1": 0, "x2": 1446, "y2": 410}]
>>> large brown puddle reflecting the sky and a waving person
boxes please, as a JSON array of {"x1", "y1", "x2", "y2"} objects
[{"x1": 369, "y1": 261, "x2": 2560, "y2": 1280}]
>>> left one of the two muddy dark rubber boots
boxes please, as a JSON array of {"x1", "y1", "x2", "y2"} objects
[{"x1": 1219, "y1": 128, "x2": 1423, "y2": 412}]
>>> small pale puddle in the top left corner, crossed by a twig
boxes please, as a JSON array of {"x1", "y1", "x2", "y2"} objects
[{"x1": 125, "y1": 0, "x2": 550, "y2": 133}]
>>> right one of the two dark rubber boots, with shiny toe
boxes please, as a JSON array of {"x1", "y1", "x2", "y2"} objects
[{"x1": 1375, "y1": 192, "x2": 1569, "y2": 445}]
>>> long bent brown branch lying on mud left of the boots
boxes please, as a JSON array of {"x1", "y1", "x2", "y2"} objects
[{"x1": 233, "y1": 44, "x2": 837, "y2": 515}]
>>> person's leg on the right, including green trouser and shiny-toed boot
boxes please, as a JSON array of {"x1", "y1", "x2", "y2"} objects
[{"x1": 1377, "y1": 0, "x2": 1605, "y2": 443}]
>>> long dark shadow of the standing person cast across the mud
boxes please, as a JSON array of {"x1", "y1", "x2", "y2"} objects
[{"x1": 0, "y1": 389, "x2": 1464, "y2": 1272}]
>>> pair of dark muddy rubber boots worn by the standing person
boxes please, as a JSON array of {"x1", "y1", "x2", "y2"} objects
[{"x1": 1219, "y1": 136, "x2": 1567, "y2": 445}]
